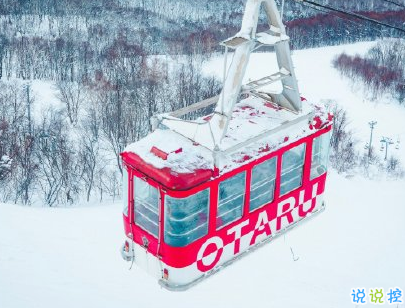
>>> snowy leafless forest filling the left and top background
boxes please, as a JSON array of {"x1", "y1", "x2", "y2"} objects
[{"x1": 0, "y1": 0, "x2": 405, "y2": 206}]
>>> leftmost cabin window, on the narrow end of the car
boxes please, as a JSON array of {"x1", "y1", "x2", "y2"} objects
[{"x1": 134, "y1": 177, "x2": 159, "y2": 237}]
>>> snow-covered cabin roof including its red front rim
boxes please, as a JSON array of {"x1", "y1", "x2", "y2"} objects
[{"x1": 122, "y1": 97, "x2": 331, "y2": 189}]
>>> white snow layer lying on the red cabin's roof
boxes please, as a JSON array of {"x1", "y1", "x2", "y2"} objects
[{"x1": 124, "y1": 97, "x2": 327, "y2": 178}]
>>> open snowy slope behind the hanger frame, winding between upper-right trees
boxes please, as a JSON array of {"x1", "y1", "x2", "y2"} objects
[{"x1": 205, "y1": 42, "x2": 405, "y2": 165}]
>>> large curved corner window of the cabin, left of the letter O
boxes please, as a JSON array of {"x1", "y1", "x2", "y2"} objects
[{"x1": 164, "y1": 189, "x2": 209, "y2": 247}]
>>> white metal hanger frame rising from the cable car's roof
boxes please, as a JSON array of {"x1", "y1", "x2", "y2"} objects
[{"x1": 153, "y1": 0, "x2": 301, "y2": 154}]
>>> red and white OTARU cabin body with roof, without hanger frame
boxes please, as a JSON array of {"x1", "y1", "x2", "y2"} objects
[{"x1": 122, "y1": 98, "x2": 331, "y2": 289}]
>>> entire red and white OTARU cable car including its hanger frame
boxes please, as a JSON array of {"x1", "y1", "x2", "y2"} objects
[{"x1": 121, "y1": 0, "x2": 332, "y2": 290}]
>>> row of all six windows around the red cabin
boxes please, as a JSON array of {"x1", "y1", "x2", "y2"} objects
[{"x1": 128, "y1": 134, "x2": 329, "y2": 247}]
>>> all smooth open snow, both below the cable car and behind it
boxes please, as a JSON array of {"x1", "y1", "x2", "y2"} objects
[{"x1": 0, "y1": 43, "x2": 405, "y2": 308}]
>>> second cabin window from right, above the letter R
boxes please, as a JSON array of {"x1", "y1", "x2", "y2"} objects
[{"x1": 280, "y1": 144, "x2": 305, "y2": 195}]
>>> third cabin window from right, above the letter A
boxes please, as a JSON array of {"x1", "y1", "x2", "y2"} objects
[{"x1": 250, "y1": 157, "x2": 277, "y2": 211}]
